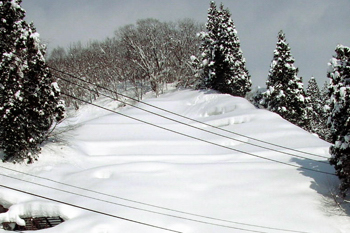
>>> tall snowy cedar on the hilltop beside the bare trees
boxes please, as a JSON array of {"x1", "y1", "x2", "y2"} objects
[{"x1": 199, "y1": 2, "x2": 252, "y2": 97}]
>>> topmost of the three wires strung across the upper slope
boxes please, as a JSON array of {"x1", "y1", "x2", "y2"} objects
[{"x1": 48, "y1": 66, "x2": 328, "y2": 159}]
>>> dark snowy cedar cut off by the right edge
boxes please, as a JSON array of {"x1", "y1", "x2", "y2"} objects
[{"x1": 327, "y1": 45, "x2": 350, "y2": 196}]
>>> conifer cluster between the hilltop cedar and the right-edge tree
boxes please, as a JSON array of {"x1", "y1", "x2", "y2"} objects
[{"x1": 249, "y1": 31, "x2": 333, "y2": 143}]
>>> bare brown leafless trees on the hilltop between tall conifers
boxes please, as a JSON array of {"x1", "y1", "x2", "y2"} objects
[{"x1": 48, "y1": 19, "x2": 203, "y2": 108}]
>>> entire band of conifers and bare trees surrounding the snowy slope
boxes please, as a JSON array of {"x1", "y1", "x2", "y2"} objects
[{"x1": 4, "y1": 0, "x2": 350, "y2": 196}]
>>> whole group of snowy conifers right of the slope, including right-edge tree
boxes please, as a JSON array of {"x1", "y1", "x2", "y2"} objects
[{"x1": 251, "y1": 31, "x2": 350, "y2": 198}]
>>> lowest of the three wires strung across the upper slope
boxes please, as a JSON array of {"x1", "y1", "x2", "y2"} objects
[{"x1": 61, "y1": 92, "x2": 336, "y2": 176}]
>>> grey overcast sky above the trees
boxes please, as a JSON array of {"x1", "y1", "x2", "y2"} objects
[{"x1": 22, "y1": 0, "x2": 350, "y2": 87}]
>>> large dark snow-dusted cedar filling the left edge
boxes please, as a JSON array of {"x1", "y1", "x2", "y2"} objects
[{"x1": 0, "y1": 0, "x2": 64, "y2": 163}]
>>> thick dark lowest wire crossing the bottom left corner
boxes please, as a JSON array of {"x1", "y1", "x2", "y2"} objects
[{"x1": 0, "y1": 184, "x2": 183, "y2": 233}]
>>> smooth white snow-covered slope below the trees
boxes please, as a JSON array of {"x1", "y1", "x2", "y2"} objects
[{"x1": 0, "y1": 90, "x2": 350, "y2": 233}]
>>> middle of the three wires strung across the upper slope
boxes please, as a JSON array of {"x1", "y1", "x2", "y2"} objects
[{"x1": 60, "y1": 75, "x2": 329, "y2": 165}]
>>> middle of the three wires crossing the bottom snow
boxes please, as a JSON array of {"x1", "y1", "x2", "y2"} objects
[{"x1": 0, "y1": 173, "x2": 290, "y2": 233}]
